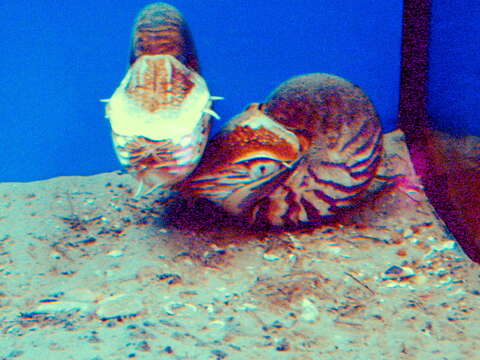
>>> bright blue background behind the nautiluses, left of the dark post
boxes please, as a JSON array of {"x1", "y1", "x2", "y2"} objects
[{"x1": 0, "y1": 0, "x2": 402, "y2": 181}]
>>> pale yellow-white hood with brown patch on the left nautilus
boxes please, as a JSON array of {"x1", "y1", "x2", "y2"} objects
[{"x1": 106, "y1": 55, "x2": 211, "y2": 142}]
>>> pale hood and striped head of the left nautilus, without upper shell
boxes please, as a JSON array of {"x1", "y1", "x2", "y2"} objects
[{"x1": 106, "y1": 55, "x2": 217, "y2": 195}]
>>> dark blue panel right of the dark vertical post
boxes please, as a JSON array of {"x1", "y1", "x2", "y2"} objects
[{"x1": 427, "y1": 0, "x2": 480, "y2": 136}]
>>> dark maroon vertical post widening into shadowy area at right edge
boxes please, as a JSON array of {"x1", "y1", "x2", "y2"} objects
[{"x1": 398, "y1": 0, "x2": 480, "y2": 263}]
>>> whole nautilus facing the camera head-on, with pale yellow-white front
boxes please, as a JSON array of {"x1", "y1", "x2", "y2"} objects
[{"x1": 105, "y1": 3, "x2": 220, "y2": 195}]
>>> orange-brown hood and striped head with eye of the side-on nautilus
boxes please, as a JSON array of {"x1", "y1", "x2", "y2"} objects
[{"x1": 180, "y1": 104, "x2": 300, "y2": 215}]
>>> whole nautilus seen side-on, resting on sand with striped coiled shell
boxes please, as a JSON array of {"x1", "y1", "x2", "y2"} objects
[{"x1": 179, "y1": 73, "x2": 382, "y2": 226}]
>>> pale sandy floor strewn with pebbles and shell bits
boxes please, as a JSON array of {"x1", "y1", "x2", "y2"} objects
[{"x1": 0, "y1": 132, "x2": 480, "y2": 360}]
